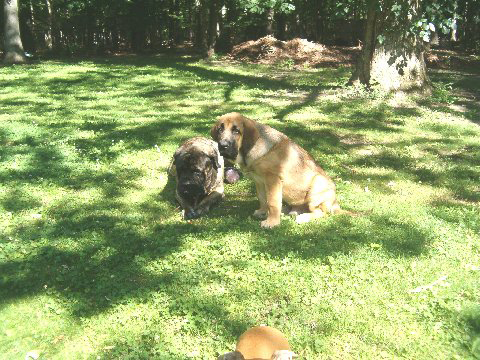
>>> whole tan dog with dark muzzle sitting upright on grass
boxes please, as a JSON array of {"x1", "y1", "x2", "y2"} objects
[{"x1": 211, "y1": 112, "x2": 342, "y2": 228}]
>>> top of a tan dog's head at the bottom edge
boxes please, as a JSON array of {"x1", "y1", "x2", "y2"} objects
[{"x1": 217, "y1": 326, "x2": 297, "y2": 360}]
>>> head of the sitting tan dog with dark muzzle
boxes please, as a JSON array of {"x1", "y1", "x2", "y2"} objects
[{"x1": 211, "y1": 112, "x2": 259, "y2": 162}]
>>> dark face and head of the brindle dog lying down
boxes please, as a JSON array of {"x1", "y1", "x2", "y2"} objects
[{"x1": 174, "y1": 147, "x2": 220, "y2": 200}]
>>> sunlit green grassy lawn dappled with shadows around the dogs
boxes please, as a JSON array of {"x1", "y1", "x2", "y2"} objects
[{"x1": 0, "y1": 56, "x2": 480, "y2": 360}]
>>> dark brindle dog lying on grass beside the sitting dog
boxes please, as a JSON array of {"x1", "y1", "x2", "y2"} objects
[{"x1": 169, "y1": 137, "x2": 224, "y2": 220}]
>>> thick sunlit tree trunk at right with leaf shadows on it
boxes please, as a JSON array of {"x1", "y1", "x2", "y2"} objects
[{"x1": 350, "y1": 0, "x2": 430, "y2": 92}]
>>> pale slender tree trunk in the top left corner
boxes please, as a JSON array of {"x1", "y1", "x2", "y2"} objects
[{"x1": 3, "y1": 0, "x2": 26, "y2": 64}]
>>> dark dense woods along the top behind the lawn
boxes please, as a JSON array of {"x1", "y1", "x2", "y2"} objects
[{"x1": 0, "y1": 0, "x2": 480, "y2": 55}]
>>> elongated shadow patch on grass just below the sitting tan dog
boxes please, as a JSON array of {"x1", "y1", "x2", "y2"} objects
[{"x1": 248, "y1": 215, "x2": 430, "y2": 261}]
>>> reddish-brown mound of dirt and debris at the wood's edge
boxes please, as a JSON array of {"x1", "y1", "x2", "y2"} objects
[{"x1": 230, "y1": 36, "x2": 359, "y2": 67}]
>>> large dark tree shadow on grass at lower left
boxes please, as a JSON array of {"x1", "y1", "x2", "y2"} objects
[{"x1": 0, "y1": 200, "x2": 188, "y2": 316}]
